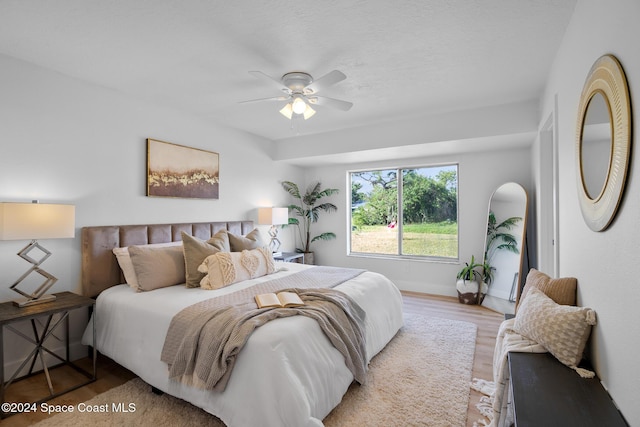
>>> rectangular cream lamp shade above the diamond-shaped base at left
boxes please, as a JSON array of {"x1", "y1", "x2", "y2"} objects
[{"x1": 0, "y1": 203, "x2": 76, "y2": 240}]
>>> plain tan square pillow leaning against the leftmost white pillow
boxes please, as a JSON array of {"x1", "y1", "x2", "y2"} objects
[{"x1": 129, "y1": 245, "x2": 185, "y2": 291}]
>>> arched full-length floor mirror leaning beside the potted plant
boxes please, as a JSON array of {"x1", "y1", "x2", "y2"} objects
[{"x1": 482, "y1": 182, "x2": 528, "y2": 314}]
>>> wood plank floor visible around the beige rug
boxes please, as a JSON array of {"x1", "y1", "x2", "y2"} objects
[{"x1": 0, "y1": 292, "x2": 503, "y2": 427}]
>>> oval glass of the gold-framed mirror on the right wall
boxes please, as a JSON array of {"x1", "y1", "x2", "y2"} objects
[{"x1": 580, "y1": 92, "x2": 613, "y2": 199}]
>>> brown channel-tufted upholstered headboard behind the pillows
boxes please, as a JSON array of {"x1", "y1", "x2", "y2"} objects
[{"x1": 82, "y1": 221, "x2": 253, "y2": 297}]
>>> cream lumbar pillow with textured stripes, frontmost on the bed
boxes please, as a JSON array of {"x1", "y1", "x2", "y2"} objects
[{"x1": 198, "y1": 247, "x2": 276, "y2": 289}]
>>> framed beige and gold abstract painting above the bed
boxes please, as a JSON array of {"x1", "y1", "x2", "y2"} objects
[{"x1": 147, "y1": 138, "x2": 220, "y2": 199}]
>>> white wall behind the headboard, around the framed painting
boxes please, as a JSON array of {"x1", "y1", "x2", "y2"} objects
[{"x1": 0, "y1": 56, "x2": 303, "y2": 372}]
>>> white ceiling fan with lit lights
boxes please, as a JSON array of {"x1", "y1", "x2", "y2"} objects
[{"x1": 243, "y1": 70, "x2": 353, "y2": 120}]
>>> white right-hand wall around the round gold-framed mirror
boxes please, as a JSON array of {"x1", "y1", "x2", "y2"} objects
[{"x1": 541, "y1": 0, "x2": 640, "y2": 426}]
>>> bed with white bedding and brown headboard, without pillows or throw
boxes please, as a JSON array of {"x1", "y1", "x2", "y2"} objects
[{"x1": 82, "y1": 221, "x2": 402, "y2": 427}]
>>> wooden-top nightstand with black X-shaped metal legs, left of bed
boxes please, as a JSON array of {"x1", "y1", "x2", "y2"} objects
[{"x1": 0, "y1": 292, "x2": 98, "y2": 418}]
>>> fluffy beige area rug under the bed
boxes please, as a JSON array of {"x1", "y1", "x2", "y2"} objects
[{"x1": 36, "y1": 315, "x2": 477, "y2": 427}]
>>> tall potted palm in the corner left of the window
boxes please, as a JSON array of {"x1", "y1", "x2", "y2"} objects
[{"x1": 282, "y1": 181, "x2": 338, "y2": 264}]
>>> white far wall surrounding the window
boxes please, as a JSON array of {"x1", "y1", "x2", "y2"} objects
[{"x1": 307, "y1": 144, "x2": 531, "y2": 296}]
